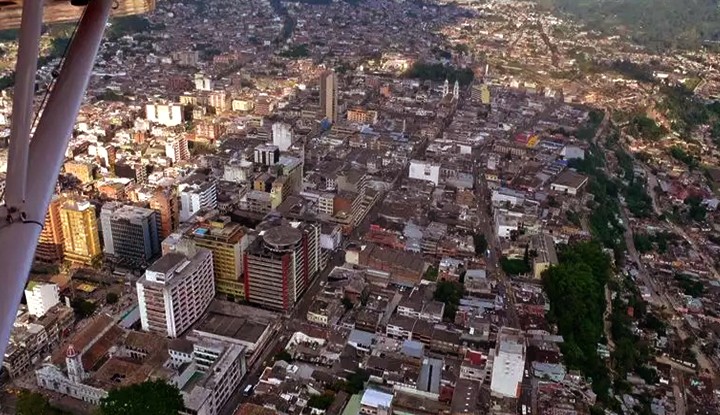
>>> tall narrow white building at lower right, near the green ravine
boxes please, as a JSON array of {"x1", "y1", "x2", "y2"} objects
[{"x1": 490, "y1": 327, "x2": 525, "y2": 398}]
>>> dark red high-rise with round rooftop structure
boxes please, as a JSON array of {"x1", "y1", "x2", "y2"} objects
[{"x1": 243, "y1": 222, "x2": 321, "y2": 311}]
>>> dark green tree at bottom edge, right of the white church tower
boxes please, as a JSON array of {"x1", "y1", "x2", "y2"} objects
[{"x1": 100, "y1": 380, "x2": 185, "y2": 415}]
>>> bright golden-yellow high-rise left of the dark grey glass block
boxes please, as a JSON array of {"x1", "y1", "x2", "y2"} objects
[{"x1": 60, "y1": 200, "x2": 102, "y2": 265}]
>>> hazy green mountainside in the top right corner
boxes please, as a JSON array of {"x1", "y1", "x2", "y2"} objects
[{"x1": 536, "y1": 0, "x2": 720, "y2": 50}]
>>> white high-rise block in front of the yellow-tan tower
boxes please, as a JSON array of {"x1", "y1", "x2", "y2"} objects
[{"x1": 137, "y1": 248, "x2": 215, "y2": 338}]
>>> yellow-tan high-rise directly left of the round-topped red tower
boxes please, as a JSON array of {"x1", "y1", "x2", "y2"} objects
[{"x1": 188, "y1": 217, "x2": 248, "y2": 299}]
